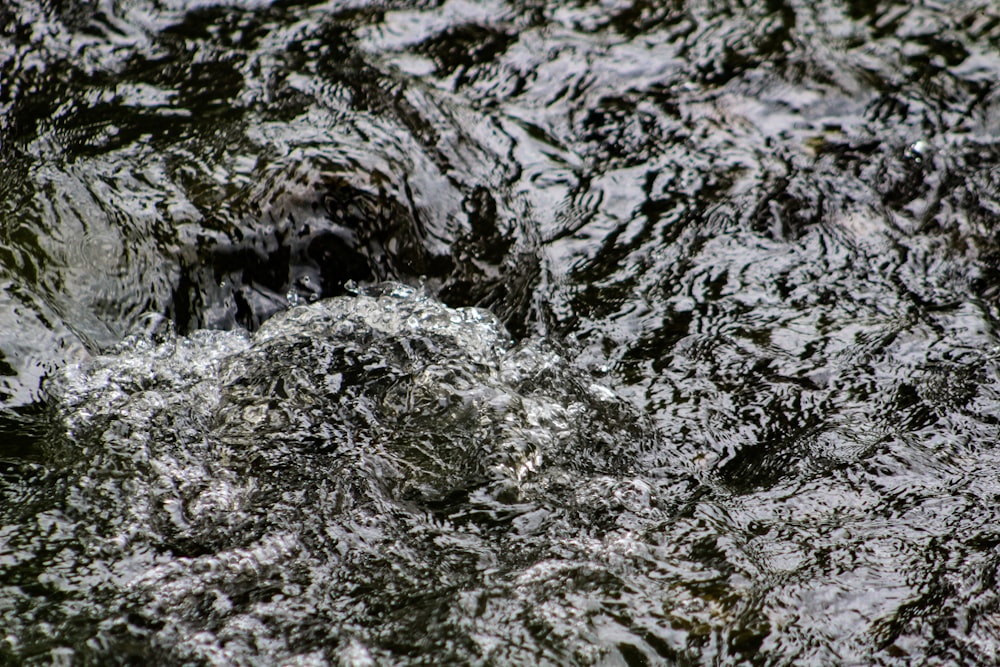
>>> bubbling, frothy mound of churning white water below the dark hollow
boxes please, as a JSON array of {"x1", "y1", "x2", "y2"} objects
[{"x1": 25, "y1": 285, "x2": 675, "y2": 664}]
